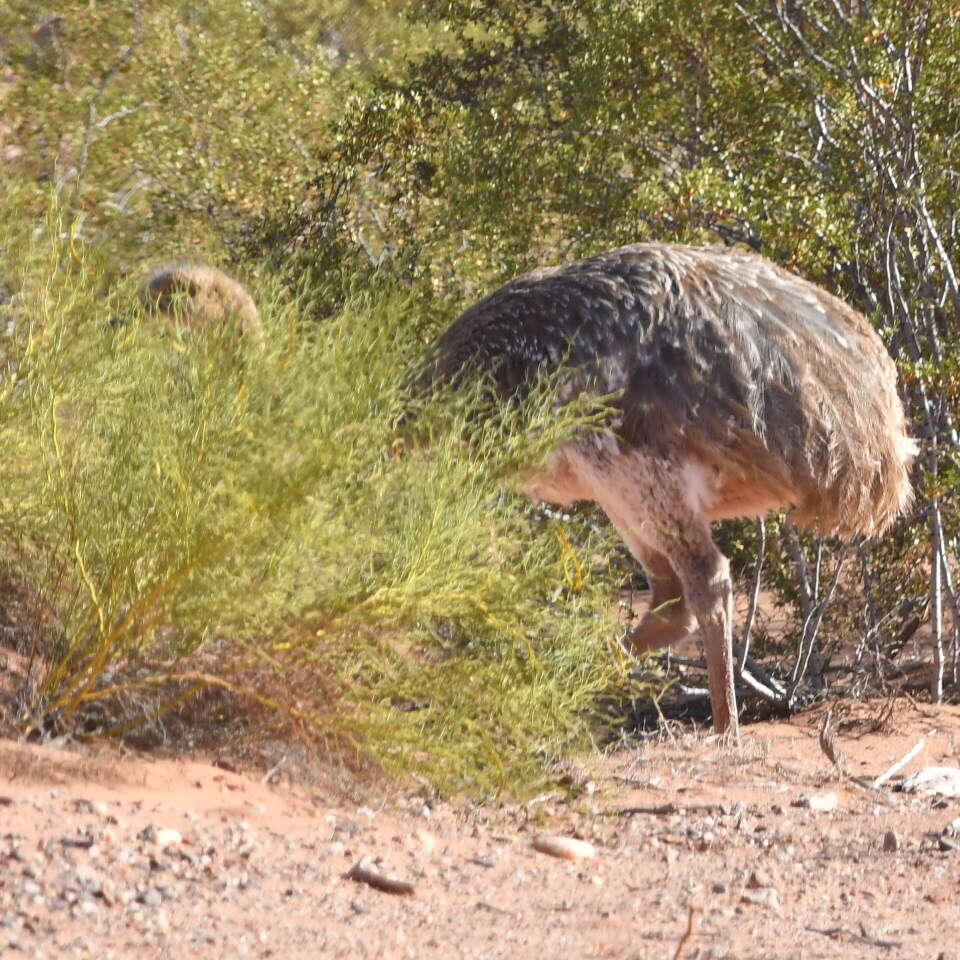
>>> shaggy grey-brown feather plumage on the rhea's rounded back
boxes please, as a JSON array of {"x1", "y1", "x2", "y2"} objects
[{"x1": 425, "y1": 244, "x2": 913, "y2": 536}]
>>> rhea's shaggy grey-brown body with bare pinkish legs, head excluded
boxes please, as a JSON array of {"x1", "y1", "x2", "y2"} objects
[{"x1": 422, "y1": 244, "x2": 914, "y2": 736}]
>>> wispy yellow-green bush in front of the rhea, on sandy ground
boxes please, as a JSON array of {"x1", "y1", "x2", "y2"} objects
[{"x1": 0, "y1": 208, "x2": 636, "y2": 790}]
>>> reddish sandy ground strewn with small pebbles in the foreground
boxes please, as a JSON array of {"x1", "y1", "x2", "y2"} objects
[{"x1": 0, "y1": 701, "x2": 960, "y2": 960}]
